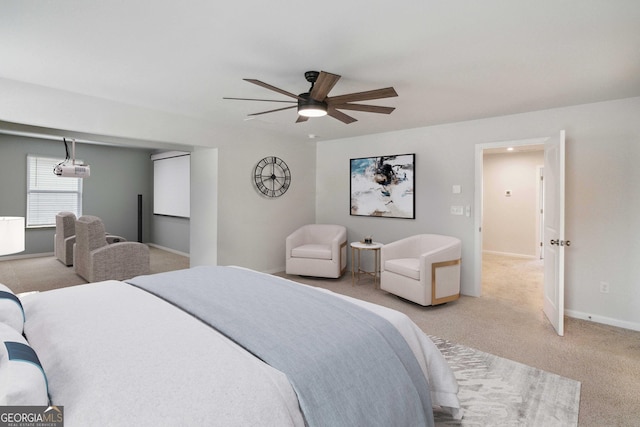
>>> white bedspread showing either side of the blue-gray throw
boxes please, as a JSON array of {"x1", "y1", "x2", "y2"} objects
[{"x1": 22, "y1": 272, "x2": 459, "y2": 426}]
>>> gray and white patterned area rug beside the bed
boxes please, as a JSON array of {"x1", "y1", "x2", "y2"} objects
[{"x1": 430, "y1": 337, "x2": 580, "y2": 427}]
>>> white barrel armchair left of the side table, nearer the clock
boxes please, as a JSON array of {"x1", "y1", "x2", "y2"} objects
[{"x1": 285, "y1": 224, "x2": 347, "y2": 279}]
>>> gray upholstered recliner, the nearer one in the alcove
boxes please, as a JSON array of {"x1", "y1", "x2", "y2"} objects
[{"x1": 73, "y1": 215, "x2": 149, "y2": 282}]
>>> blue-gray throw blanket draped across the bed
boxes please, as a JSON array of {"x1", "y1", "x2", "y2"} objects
[{"x1": 128, "y1": 267, "x2": 433, "y2": 427}]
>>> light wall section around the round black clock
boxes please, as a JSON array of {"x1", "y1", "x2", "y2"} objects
[{"x1": 218, "y1": 138, "x2": 316, "y2": 273}]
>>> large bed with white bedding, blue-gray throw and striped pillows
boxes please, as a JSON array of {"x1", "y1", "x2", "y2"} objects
[{"x1": 0, "y1": 267, "x2": 462, "y2": 427}]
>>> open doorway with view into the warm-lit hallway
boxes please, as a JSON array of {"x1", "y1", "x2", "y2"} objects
[{"x1": 476, "y1": 138, "x2": 546, "y2": 305}]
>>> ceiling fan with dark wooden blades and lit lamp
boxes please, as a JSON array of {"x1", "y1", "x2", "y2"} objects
[{"x1": 223, "y1": 71, "x2": 398, "y2": 124}]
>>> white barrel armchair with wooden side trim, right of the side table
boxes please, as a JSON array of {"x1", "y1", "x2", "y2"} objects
[{"x1": 380, "y1": 234, "x2": 462, "y2": 306}]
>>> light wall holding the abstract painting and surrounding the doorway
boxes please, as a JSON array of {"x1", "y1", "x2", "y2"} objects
[{"x1": 316, "y1": 98, "x2": 640, "y2": 329}]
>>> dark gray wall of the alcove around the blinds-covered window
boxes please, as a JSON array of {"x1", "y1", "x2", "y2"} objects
[{"x1": 0, "y1": 134, "x2": 154, "y2": 255}]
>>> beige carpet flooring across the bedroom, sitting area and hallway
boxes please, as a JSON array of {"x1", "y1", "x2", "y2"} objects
[{"x1": 0, "y1": 247, "x2": 640, "y2": 427}]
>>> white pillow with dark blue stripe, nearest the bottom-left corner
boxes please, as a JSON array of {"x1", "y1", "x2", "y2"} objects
[{"x1": 0, "y1": 323, "x2": 49, "y2": 406}]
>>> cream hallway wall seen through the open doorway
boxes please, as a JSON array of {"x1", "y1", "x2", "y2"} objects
[{"x1": 482, "y1": 150, "x2": 544, "y2": 257}]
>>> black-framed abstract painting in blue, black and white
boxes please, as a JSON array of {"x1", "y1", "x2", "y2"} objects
[{"x1": 350, "y1": 154, "x2": 415, "y2": 219}]
